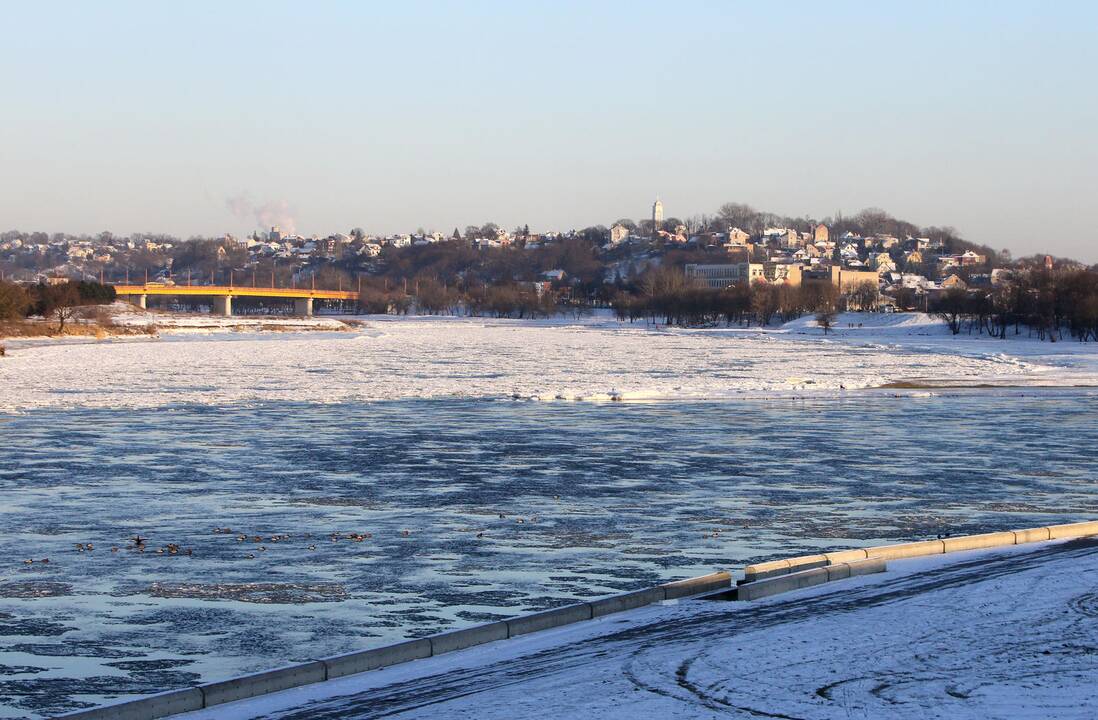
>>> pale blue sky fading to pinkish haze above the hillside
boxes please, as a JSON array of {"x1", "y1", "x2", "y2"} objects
[{"x1": 0, "y1": 0, "x2": 1098, "y2": 261}]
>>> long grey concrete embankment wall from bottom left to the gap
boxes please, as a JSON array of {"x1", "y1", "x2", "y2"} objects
[{"x1": 57, "y1": 572, "x2": 732, "y2": 720}]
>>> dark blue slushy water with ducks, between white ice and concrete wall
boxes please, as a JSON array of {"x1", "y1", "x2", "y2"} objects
[{"x1": 0, "y1": 390, "x2": 1098, "y2": 717}]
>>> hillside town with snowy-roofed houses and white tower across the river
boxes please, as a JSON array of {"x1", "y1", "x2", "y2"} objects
[{"x1": 0, "y1": 200, "x2": 1085, "y2": 329}]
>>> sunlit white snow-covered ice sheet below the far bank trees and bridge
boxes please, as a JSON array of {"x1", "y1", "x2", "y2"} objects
[{"x1": 0, "y1": 307, "x2": 1098, "y2": 412}]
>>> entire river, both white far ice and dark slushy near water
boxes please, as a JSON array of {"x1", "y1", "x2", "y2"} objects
[{"x1": 0, "y1": 318, "x2": 1098, "y2": 718}]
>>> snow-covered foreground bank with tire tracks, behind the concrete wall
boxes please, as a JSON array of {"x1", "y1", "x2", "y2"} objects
[{"x1": 180, "y1": 539, "x2": 1098, "y2": 720}]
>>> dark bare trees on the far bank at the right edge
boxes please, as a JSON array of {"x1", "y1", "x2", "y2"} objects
[{"x1": 931, "y1": 269, "x2": 1098, "y2": 341}]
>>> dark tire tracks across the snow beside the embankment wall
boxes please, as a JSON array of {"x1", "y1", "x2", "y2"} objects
[{"x1": 251, "y1": 540, "x2": 1098, "y2": 720}]
